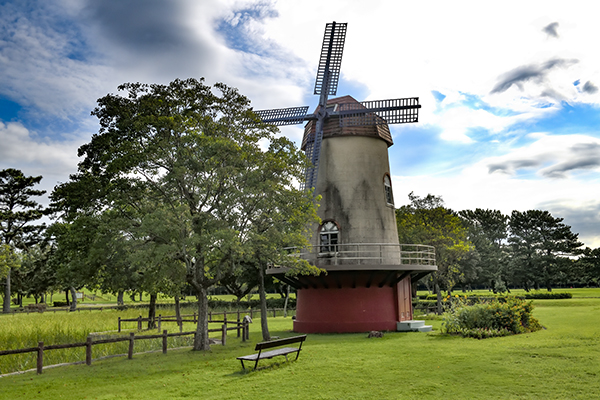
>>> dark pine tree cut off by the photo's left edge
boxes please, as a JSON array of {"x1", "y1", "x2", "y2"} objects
[{"x1": 0, "y1": 168, "x2": 46, "y2": 313}]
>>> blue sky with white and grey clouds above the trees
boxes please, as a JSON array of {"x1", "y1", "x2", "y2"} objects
[{"x1": 0, "y1": 0, "x2": 600, "y2": 248}]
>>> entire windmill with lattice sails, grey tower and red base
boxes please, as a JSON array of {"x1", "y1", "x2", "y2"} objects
[{"x1": 256, "y1": 22, "x2": 437, "y2": 333}]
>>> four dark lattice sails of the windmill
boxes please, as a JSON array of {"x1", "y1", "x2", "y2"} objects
[{"x1": 255, "y1": 21, "x2": 421, "y2": 190}]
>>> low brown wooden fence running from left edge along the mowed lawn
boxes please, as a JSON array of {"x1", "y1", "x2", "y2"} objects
[{"x1": 0, "y1": 321, "x2": 250, "y2": 374}]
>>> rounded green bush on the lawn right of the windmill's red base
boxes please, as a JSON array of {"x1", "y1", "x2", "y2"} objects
[{"x1": 442, "y1": 297, "x2": 541, "y2": 339}]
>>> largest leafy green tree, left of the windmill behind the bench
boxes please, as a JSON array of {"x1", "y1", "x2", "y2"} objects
[{"x1": 53, "y1": 79, "x2": 314, "y2": 350}]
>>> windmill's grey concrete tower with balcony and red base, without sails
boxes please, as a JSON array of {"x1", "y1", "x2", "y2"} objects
[{"x1": 269, "y1": 96, "x2": 437, "y2": 333}]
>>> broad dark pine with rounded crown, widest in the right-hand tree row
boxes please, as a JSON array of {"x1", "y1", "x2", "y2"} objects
[{"x1": 508, "y1": 210, "x2": 583, "y2": 291}]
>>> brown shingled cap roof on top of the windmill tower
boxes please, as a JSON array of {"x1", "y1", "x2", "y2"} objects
[{"x1": 302, "y1": 96, "x2": 394, "y2": 150}]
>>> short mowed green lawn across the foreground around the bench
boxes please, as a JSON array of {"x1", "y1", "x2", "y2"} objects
[{"x1": 0, "y1": 298, "x2": 600, "y2": 399}]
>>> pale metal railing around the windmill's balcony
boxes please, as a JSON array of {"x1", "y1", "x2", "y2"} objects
[{"x1": 286, "y1": 243, "x2": 436, "y2": 266}]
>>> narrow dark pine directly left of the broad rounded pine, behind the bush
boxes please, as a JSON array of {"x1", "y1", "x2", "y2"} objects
[{"x1": 459, "y1": 208, "x2": 508, "y2": 293}]
